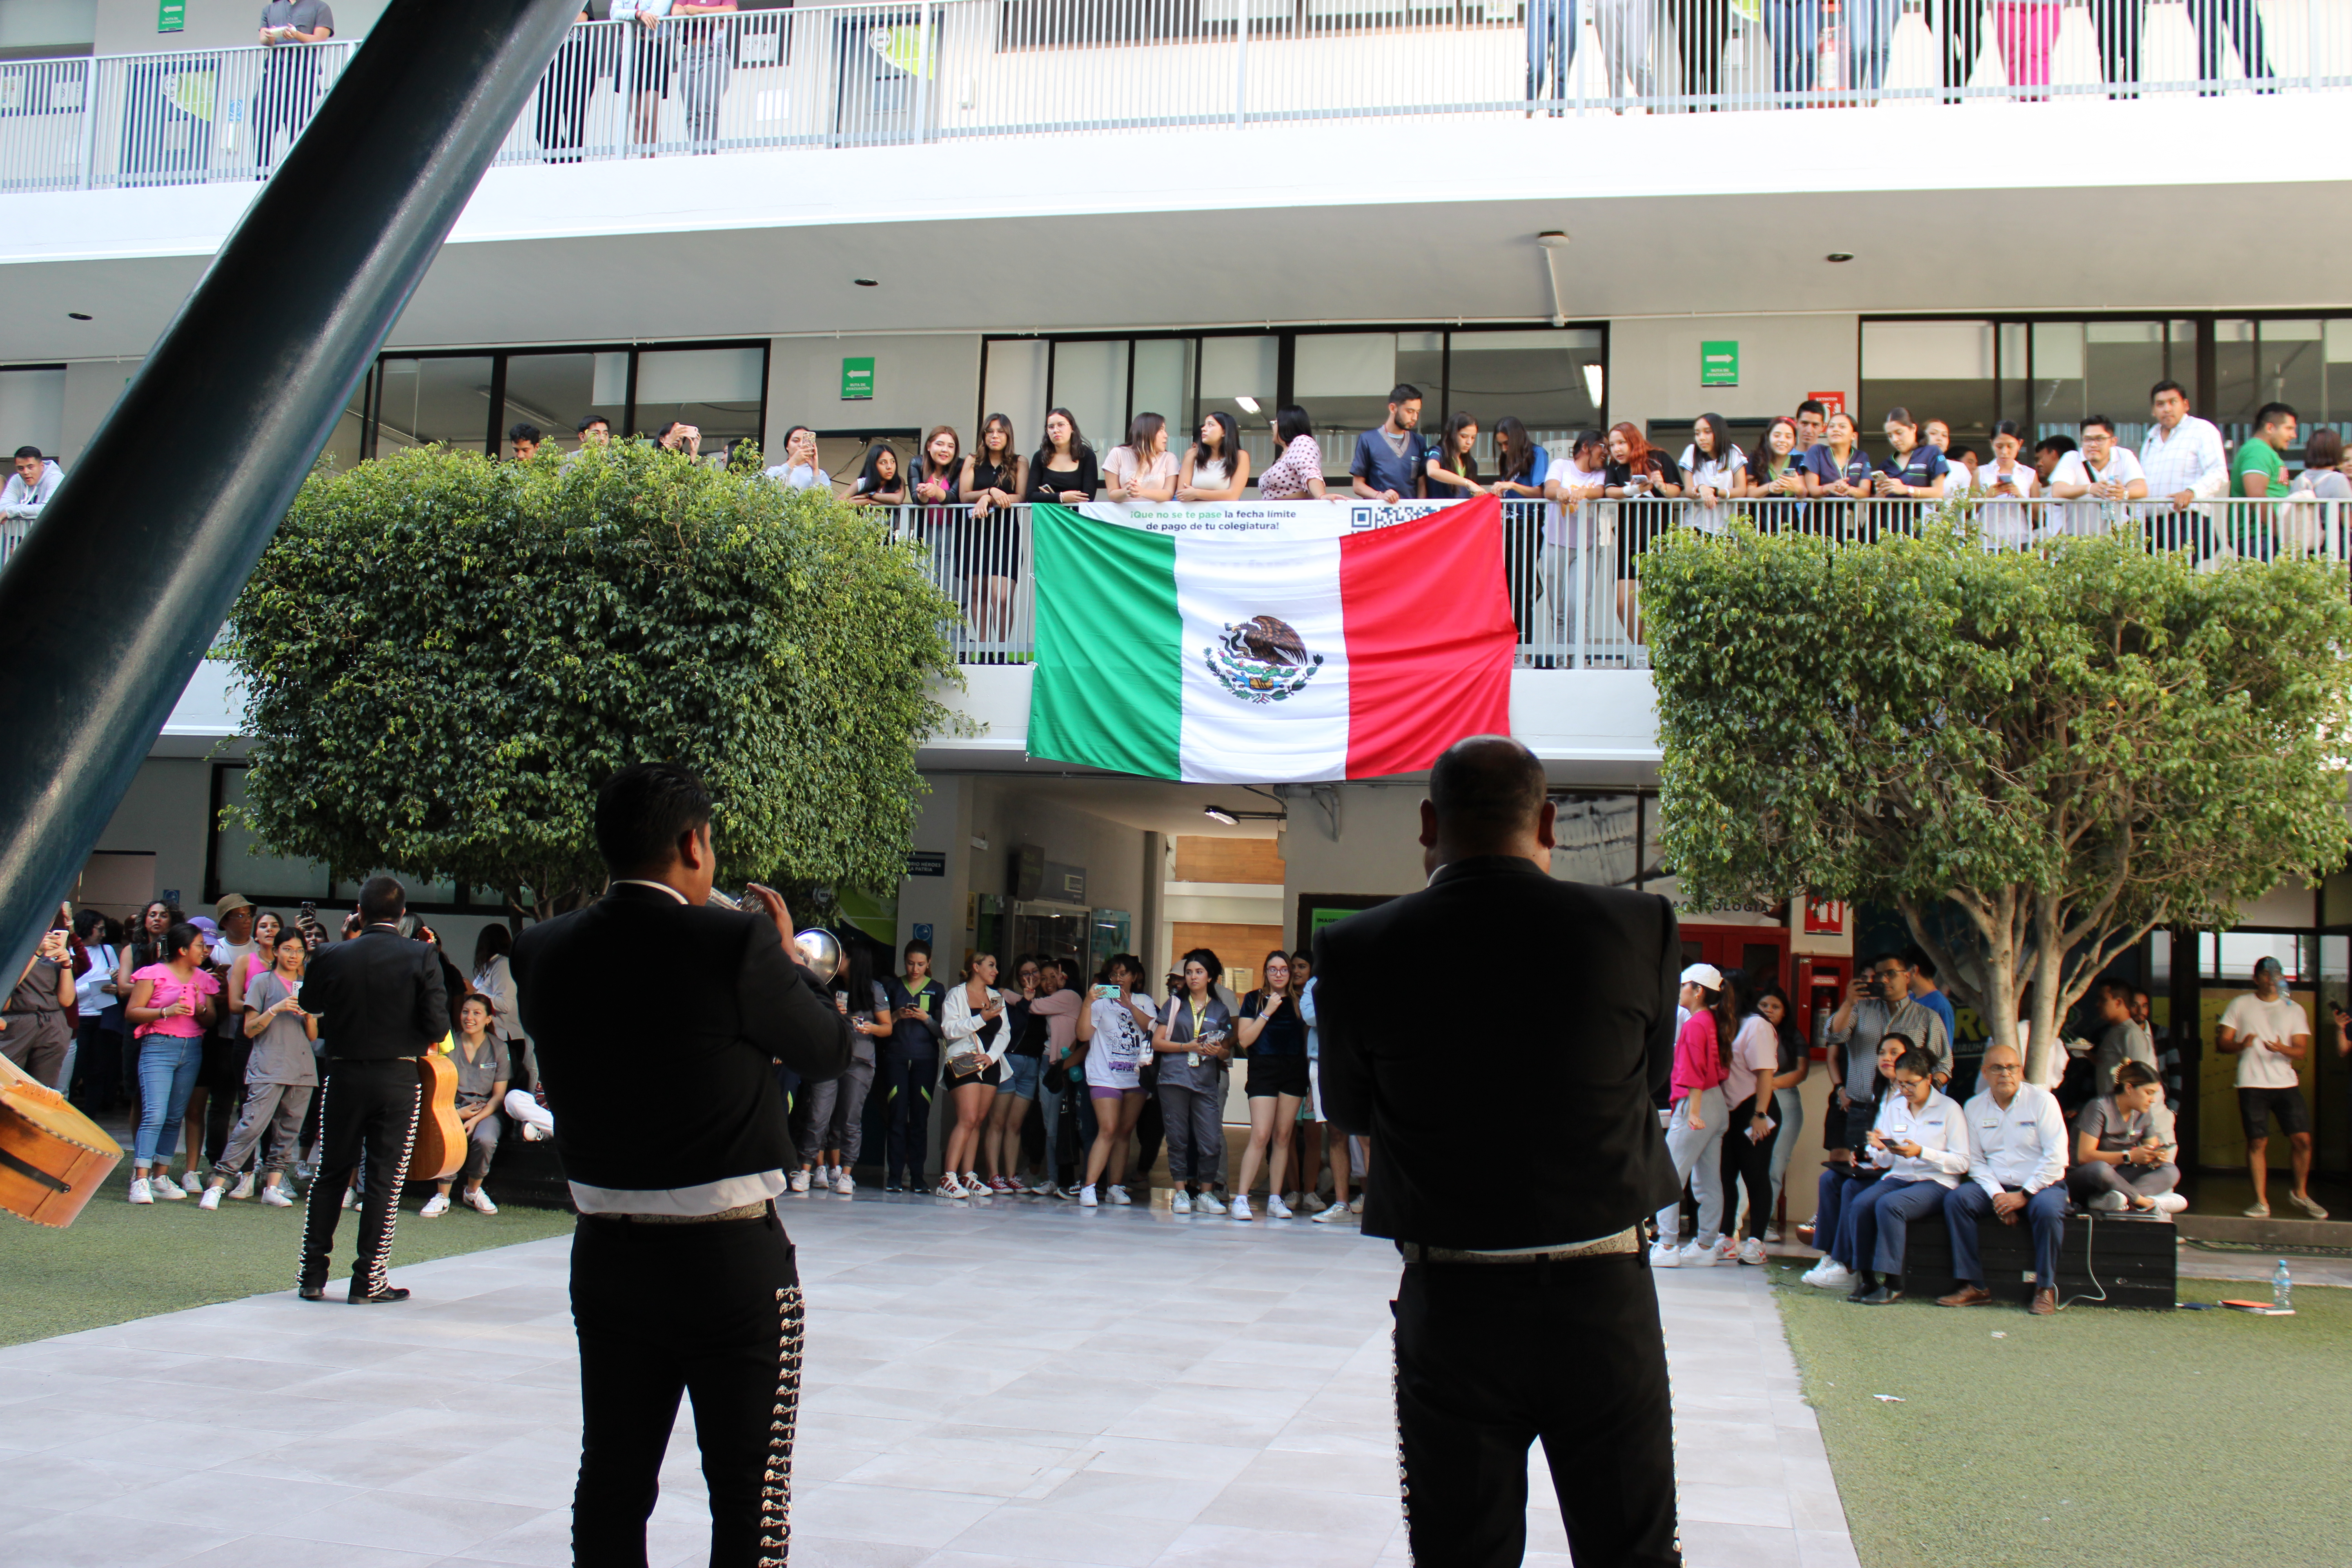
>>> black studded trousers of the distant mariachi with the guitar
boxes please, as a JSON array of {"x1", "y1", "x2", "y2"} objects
[{"x1": 301, "y1": 1056, "x2": 423, "y2": 1295}]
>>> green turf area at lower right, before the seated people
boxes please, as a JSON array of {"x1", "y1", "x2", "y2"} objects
[{"x1": 1778, "y1": 1265, "x2": 2352, "y2": 1568}]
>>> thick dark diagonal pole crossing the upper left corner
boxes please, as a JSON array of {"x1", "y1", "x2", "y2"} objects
[{"x1": 0, "y1": 0, "x2": 579, "y2": 980}]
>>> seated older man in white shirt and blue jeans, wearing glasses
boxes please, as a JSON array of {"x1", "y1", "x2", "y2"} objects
[{"x1": 1936, "y1": 1046, "x2": 2070, "y2": 1316}]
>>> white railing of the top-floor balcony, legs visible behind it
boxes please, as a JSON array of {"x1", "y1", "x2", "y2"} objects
[{"x1": 0, "y1": 0, "x2": 2352, "y2": 191}]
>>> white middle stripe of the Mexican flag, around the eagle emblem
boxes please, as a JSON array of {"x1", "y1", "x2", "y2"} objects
[{"x1": 1176, "y1": 538, "x2": 1348, "y2": 783}]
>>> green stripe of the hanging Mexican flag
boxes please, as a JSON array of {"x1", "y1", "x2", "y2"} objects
[{"x1": 1028, "y1": 505, "x2": 1183, "y2": 778}]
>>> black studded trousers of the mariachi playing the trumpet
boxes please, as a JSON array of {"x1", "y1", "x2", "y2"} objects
[{"x1": 572, "y1": 1203, "x2": 802, "y2": 1568}]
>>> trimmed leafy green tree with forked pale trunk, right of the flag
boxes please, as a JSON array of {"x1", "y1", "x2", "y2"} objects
[{"x1": 1642, "y1": 519, "x2": 2352, "y2": 1072}]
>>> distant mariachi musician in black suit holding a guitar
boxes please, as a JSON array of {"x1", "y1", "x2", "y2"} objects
[{"x1": 296, "y1": 877, "x2": 452, "y2": 1305}]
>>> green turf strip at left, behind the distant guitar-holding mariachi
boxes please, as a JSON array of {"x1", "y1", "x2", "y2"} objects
[{"x1": 0, "y1": 1173, "x2": 572, "y2": 1345}]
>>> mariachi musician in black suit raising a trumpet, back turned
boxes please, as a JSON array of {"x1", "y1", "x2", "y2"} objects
[{"x1": 513, "y1": 764, "x2": 856, "y2": 1568}]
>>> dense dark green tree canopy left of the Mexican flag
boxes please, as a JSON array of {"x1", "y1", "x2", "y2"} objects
[{"x1": 226, "y1": 439, "x2": 955, "y2": 917}]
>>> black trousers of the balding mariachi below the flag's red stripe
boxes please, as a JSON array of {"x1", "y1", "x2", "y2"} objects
[{"x1": 1397, "y1": 1253, "x2": 1682, "y2": 1568}]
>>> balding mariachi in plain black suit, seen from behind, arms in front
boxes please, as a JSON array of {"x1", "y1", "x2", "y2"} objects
[{"x1": 1315, "y1": 736, "x2": 1682, "y2": 1568}]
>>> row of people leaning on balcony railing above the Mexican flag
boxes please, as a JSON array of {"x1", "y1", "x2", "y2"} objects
[{"x1": 710, "y1": 381, "x2": 2352, "y2": 517}]
